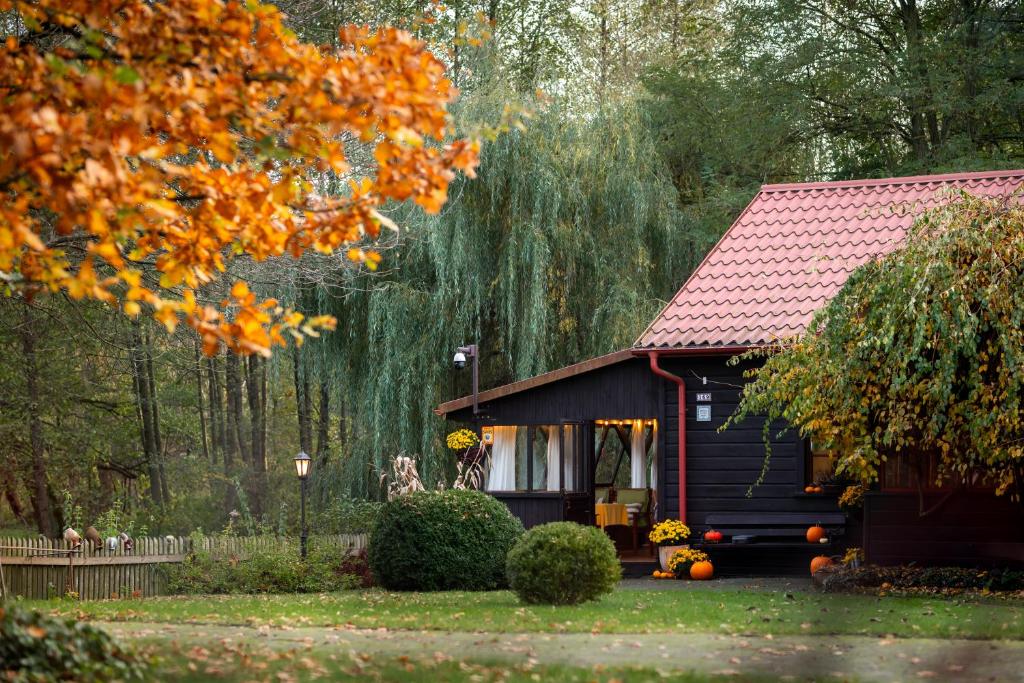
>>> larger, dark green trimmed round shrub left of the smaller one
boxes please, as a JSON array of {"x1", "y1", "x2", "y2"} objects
[{"x1": 367, "y1": 490, "x2": 523, "y2": 591}]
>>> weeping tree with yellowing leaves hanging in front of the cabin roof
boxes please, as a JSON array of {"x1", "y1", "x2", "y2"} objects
[{"x1": 730, "y1": 196, "x2": 1024, "y2": 507}]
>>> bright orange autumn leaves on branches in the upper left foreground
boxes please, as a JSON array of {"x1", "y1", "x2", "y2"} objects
[{"x1": 0, "y1": 0, "x2": 476, "y2": 355}]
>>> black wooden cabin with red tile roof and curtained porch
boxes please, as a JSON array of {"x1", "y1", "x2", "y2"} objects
[{"x1": 437, "y1": 171, "x2": 1024, "y2": 573}]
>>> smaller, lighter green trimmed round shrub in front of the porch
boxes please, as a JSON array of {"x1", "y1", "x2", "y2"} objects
[{"x1": 507, "y1": 522, "x2": 623, "y2": 605}]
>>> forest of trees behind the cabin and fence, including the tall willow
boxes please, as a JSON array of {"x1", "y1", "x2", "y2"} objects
[{"x1": 0, "y1": 0, "x2": 1024, "y2": 535}]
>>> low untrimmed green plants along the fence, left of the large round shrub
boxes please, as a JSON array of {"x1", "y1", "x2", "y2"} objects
[{"x1": 167, "y1": 540, "x2": 367, "y2": 594}]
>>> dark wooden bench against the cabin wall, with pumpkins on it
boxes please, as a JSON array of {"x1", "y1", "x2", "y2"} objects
[{"x1": 694, "y1": 512, "x2": 846, "y2": 548}]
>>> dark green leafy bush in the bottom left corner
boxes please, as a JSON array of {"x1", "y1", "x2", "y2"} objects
[{"x1": 0, "y1": 603, "x2": 147, "y2": 683}]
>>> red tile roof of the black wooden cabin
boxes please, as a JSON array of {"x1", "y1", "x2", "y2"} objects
[{"x1": 634, "y1": 170, "x2": 1024, "y2": 348}]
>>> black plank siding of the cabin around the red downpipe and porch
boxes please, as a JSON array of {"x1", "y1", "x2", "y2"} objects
[{"x1": 450, "y1": 356, "x2": 836, "y2": 528}]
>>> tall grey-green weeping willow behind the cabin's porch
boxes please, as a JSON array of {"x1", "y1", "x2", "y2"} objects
[{"x1": 303, "y1": 93, "x2": 714, "y2": 495}]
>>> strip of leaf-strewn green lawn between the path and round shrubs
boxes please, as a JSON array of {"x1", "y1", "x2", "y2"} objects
[{"x1": 27, "y1": 590, "x2": 1024, "y2": 640}]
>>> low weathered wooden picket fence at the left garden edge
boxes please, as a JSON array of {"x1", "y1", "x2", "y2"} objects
[{"x1": 0, "y1": 535, "x2": 367, "y2": 600}]
